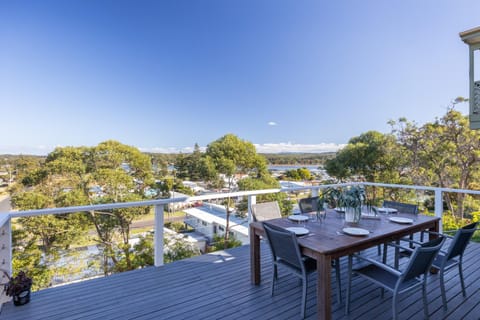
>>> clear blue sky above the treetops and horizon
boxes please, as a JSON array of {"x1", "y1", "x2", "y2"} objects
[{"x1": 0, "y1": 0, "x2": 480, "y2": 154}]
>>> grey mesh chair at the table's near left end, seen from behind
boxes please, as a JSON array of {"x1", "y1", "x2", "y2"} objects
[{"x1": 263, "y1": 222, "x2": 317, "y2": 319}]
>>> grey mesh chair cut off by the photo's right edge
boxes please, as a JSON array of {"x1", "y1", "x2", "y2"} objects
[{"x1": 433, "y1": 222, "x2": 478, "y2": 310}]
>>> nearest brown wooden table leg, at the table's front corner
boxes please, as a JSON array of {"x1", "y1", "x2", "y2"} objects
[{"x1": 316, "y1": 255, "x2": 332, "y2": 320}]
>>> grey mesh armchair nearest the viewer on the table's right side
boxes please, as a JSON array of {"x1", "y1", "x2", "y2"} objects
[{"x1": 345, "y1": 236, "x2": 445, "y2": 320}]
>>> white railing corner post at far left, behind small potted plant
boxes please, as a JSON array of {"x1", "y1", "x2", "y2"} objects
[{"x1": 0, "y1": 217, "x2": 12, "y2": 304}]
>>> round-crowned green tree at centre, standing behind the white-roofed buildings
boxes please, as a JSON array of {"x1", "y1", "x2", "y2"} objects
[{"x1": 202, "y1": 134, "x2": 268, "y2": 246}]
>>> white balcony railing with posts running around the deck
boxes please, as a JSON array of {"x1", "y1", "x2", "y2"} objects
[{"x1": 0, "y1": 182, "x2": 480, "y2": 305}]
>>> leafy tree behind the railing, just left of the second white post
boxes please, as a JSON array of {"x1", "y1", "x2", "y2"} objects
[{"x1": 86, "y1": 141, "x2": 153, "y2": 274}]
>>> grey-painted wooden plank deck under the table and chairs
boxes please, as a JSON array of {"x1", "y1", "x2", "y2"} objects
[{"x1": 0, "y1": 244, "x2": 480, "y2": 320}]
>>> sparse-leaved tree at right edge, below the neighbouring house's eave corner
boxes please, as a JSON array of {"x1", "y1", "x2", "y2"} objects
[{"x1": 392, "y1": 108, "x2": 480, "y2": 218}]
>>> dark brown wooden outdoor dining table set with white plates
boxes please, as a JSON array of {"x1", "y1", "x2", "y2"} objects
[{"x1": 250, "y1": 211, "x2": 440, "y2": 319}]
